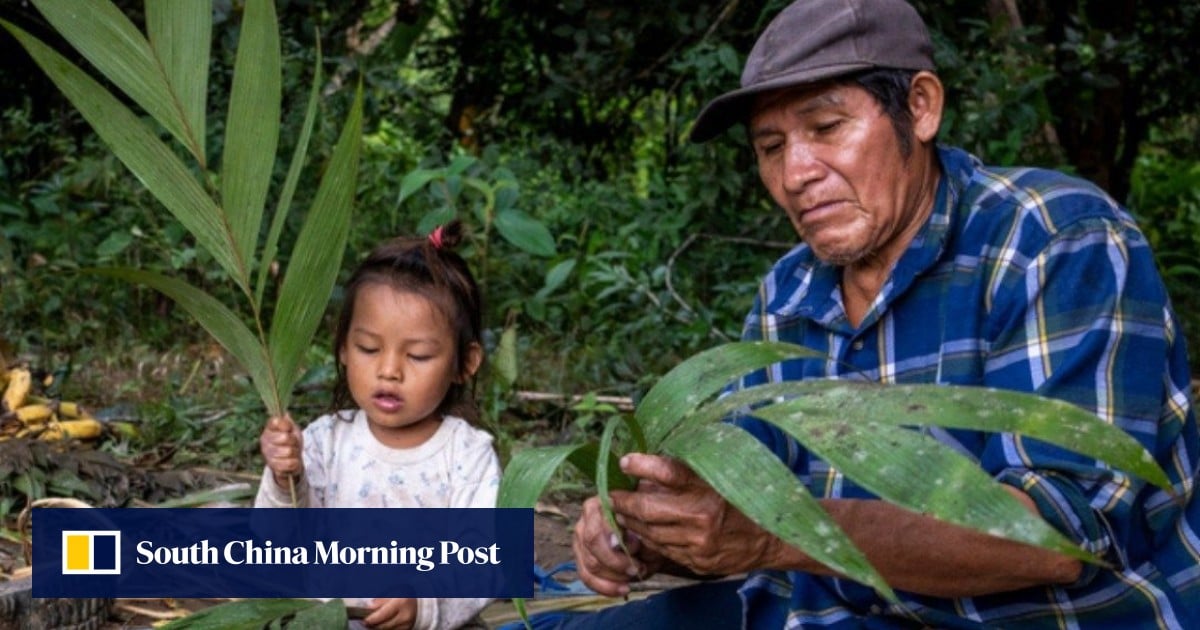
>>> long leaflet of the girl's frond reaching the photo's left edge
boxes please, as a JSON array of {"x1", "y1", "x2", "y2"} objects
[{"x1": 0, "y1": 20, "x2": 248, "y2": 294}]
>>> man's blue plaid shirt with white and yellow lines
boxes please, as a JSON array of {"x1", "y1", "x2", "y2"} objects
[{"x1": 739, "y1": 148, "x2": 1200, "y2": 629}]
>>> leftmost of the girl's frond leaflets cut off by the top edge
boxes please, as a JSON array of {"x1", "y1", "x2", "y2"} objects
[{"x1": 29, "y1": 0, "x2": 199, "y2": 162}]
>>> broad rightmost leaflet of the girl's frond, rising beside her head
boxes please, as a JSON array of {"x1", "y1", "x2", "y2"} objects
[{"x1": 269, "y1": 85, "x2": 362, "y2": 409}]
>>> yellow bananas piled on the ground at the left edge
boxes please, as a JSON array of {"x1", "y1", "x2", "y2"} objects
[{"x1": 0, "y1": 366, "x2": 104, "y2": 440}]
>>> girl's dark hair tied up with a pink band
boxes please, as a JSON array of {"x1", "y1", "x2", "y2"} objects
[{"x1": 334, "y1": 221, "x2": 484, "y2": 422}]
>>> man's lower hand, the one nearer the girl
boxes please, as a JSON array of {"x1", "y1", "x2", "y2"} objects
[{"x1": 571, "y1": 491, "x2": 664, "y2": 598}]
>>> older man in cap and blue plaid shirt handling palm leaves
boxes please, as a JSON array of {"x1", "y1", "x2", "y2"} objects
[{"x1": 575, "y1": 0, "x2": 1200, "y2": 628}]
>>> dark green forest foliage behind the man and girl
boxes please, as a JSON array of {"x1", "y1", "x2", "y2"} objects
[{"x1": 0, "y1": 0, "x2": 1200, "y2": 467}]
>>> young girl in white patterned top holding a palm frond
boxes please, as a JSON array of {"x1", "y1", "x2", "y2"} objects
[{"x1": 254, "y1": 222, "x2": 500, "y2": 629}]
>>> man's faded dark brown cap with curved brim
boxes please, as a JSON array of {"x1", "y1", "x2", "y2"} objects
[{"x1": 690, "y1": 0, "x2": 934, "y2": 143}]
